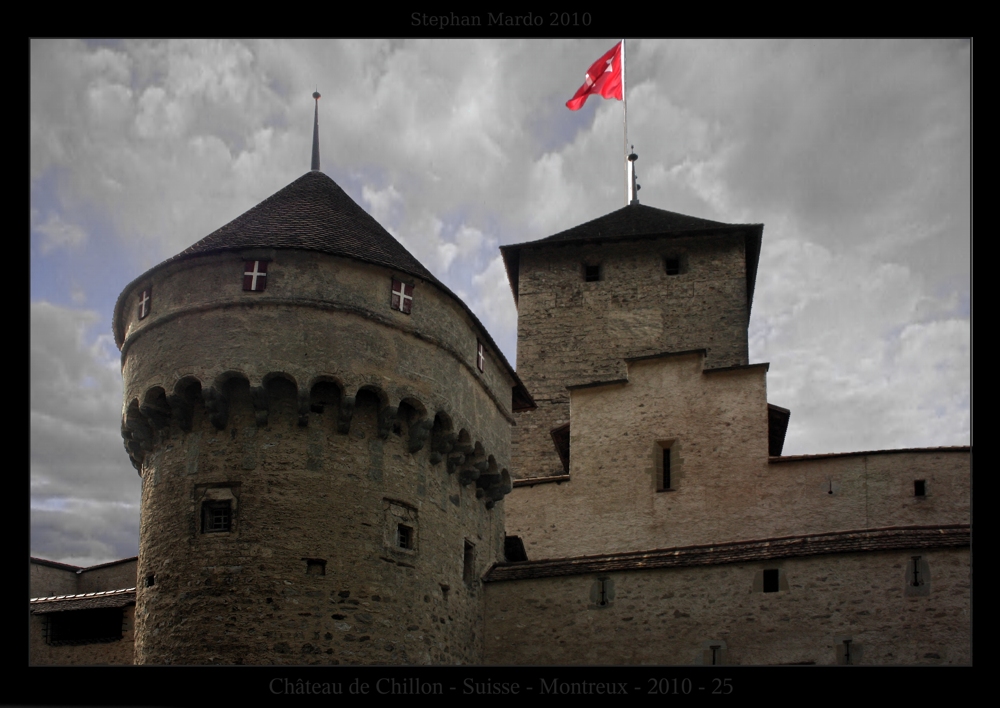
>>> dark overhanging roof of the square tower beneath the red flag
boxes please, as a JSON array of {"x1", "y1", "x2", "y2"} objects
[{"x1": 500, "y1": 198, "x2": 764, "y2": 311}]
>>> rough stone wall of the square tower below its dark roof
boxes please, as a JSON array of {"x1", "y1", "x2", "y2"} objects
[{"x1": 512, "y1": 235, "x2": 748, "y2": 478}]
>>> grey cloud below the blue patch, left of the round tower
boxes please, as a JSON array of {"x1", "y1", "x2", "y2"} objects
[{"x1": 30, "y1": 302, "x2": 139, "y2": 562}]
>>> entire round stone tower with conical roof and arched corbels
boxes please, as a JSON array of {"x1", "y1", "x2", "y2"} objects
[{"x1": 114, "y1": 101, "x2": 533, "y2": 664}]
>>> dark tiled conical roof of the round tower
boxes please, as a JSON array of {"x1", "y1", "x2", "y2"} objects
[{"x1": 170, "y1": 171, "x2": 439, "y2": 284}]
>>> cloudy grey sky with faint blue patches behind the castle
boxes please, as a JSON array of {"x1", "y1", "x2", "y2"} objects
[{"x1": 30, "y1": 38, "x2": 971, "y2": 565}]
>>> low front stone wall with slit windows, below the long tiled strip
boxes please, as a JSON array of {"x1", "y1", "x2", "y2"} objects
[{"x1": 486, "y1": 549, "x2": 971, "y2": 665}]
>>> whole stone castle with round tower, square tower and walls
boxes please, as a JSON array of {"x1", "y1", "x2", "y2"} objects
[{"x1": 29, "y1": 96, "x2": 971, "y2": 665}]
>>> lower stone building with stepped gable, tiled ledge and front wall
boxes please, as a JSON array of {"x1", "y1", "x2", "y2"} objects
[{"x1": 484, "y1": 351, "x2": 971, "y2": 665}]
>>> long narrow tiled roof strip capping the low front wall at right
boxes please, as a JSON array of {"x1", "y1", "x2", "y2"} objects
[{"x1": 483, "y1": 524, "x2": 970, "y2": 582}]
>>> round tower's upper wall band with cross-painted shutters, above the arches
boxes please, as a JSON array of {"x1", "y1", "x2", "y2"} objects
[{"x1": 122, "y1": 250, "x2": 514, "y2": 456}]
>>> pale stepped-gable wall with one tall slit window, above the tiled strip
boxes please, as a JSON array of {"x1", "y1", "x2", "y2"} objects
[{"x1": 507, "y1": 354, "x2": 970, "y2": 560}]
